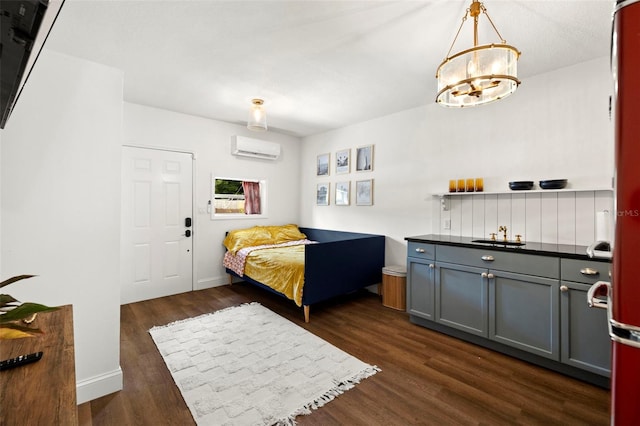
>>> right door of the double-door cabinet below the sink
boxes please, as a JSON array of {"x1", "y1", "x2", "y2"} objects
[{"x1": 489, "y1": 270, "x2": 560, "y2": 361}]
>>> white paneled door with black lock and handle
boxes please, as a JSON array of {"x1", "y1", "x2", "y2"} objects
[{"x1": 120, "y1": 147, "x2": 193, "y2": 304}]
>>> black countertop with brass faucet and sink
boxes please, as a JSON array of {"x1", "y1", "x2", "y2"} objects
[{"x1": 405, "y1": 234, "x2": 611, "y2": 263}]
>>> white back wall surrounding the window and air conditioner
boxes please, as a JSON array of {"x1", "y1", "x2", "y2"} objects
[{"x1": 124, "y1": 103, "x2": 301, "y2": 289}]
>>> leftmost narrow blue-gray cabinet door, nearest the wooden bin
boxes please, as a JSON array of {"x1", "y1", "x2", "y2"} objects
[{"x1": 407, "y1": 258, "x2": 435, "y2": 320}]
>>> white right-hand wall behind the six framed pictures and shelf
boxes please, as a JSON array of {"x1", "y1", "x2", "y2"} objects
[{"x1": 300, "y1": 58, "x2": 613, "y2": 264}]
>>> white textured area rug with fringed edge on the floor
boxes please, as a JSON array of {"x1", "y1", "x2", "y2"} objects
[{"x1": 149, "y1": 302, "x2": 380, "y2": 426}]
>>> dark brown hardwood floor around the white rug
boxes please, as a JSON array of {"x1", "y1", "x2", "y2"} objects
[{"x1": 78, "y1": 283, "x2": 609, "y2": 426}]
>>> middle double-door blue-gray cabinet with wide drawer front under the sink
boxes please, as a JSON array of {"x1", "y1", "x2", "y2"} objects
[{"x1": 435, "y1": 245, "x2": 560, "y2": 361}]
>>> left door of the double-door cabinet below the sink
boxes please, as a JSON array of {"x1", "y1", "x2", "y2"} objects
[{"x1": 435, "y1": 262, "x2": 488, "y2": 337}]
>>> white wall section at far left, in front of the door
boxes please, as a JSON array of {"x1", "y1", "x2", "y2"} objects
[{"x1": 0, "y1": 50, "x2": 123, "y2": 403}]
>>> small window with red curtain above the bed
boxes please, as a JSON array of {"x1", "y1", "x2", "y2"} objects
[{"x1": 211, "y1": 177, "x2": 267, "y2": 219}]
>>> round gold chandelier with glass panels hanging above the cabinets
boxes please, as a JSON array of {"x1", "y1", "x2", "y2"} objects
[{"x1": 436, "y1": 0, "x2": 520, "y2": 107}]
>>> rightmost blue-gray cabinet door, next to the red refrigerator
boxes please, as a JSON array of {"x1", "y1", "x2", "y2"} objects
[{"x1": 560, "y1": 281, "x2": 611, "y2": 377}]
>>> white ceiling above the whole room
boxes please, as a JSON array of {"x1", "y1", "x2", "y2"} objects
[{"x1": 47, "y1": 0, "x2": 614, "y2": 136}]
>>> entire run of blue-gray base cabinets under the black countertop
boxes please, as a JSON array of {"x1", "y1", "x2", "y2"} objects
[{"x1": 407, "y1": 241, "x2": 611, "y2": 385}]
